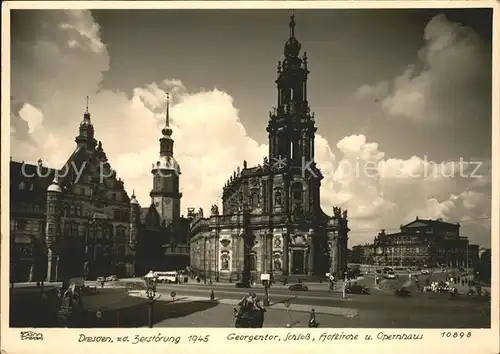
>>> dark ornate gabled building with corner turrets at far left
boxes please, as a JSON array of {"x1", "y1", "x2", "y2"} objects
[{"x1": 10, "y1": 106, "x2": 136, "y2": 281}]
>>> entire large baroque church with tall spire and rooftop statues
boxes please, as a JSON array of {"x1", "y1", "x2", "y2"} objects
[{"x1": 190, "y1": 16, "x2": 349, "y2": 281}]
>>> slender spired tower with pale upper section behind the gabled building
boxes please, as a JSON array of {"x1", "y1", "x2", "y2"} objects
[{"x1": 150, "y1": 94, "x2": 182, "y2": 225}]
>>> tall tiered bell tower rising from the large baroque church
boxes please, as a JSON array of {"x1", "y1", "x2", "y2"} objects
[{"x1": 267, "y1": 13, "x2": 323, "y2": 217}]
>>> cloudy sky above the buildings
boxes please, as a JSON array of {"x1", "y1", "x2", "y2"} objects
[{"x1": 11, "y1": 9, "x2": 492, "y2": 246}]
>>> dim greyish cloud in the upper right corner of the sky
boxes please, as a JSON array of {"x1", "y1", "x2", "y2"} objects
[{"x1": 356, "y1": 14, "x2": 491, "y2": 123}]
